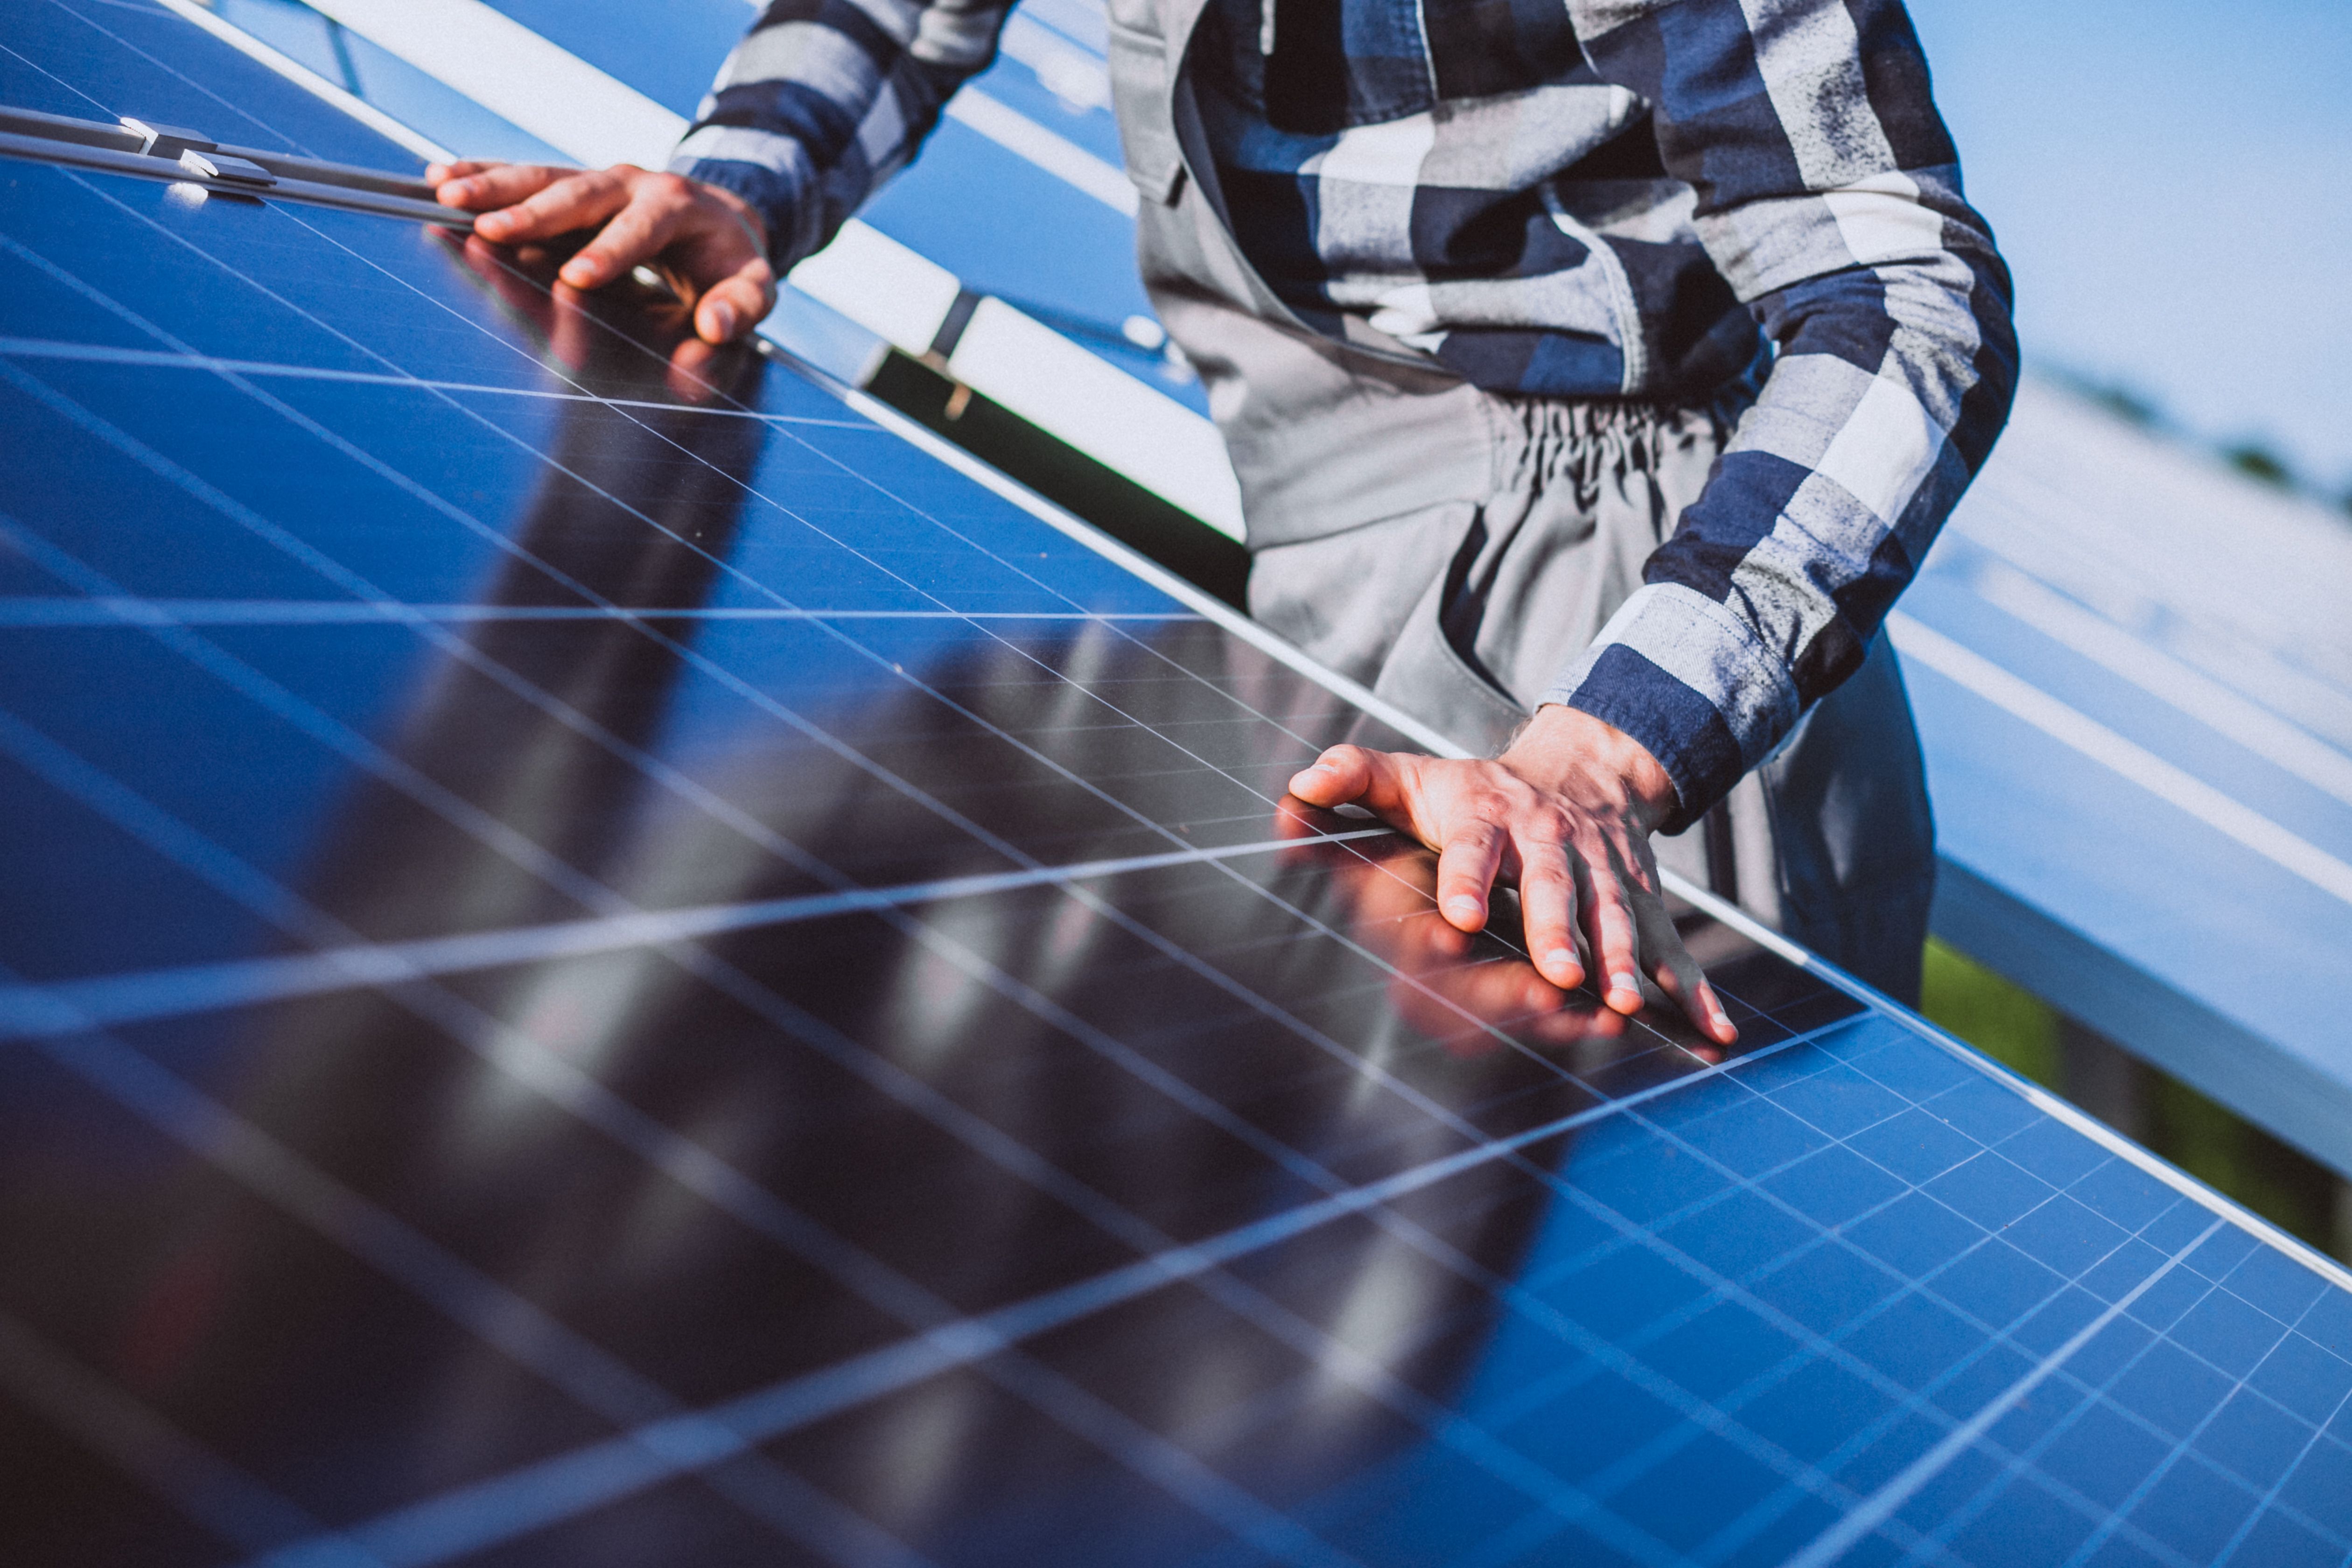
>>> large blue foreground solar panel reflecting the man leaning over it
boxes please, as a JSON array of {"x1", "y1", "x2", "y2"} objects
[{"x1": 0, "y1": 2, "x2": 2352, "y2": 1566}]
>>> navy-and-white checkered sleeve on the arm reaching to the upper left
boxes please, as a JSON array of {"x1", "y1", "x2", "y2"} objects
[{"x1": 670, "y1": 0, "x2": 1011, "y2": 270}]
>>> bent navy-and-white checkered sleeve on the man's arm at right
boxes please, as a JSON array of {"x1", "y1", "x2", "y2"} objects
[{"x1": 1543, "y1": 0, "x2": 2018, "y2": 830}]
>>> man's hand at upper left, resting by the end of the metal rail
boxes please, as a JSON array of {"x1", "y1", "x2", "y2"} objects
[{"x1": 426, "y1": 162, "x2": 776, "y2": 343}]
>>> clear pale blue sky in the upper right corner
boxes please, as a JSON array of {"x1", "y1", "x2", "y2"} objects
[{"x1": 1910, "y1": 0, "x2": 2352, "y2": 494}]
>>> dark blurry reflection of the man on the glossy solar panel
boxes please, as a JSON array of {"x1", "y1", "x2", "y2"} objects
[{"x1": 0, "y1": 223, "x2": 1862, "y2": 1561}]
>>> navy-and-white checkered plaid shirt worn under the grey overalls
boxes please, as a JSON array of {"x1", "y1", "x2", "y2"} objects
[{"x1": 672, "y1": 0, "x2": 2018, "y2": 825}]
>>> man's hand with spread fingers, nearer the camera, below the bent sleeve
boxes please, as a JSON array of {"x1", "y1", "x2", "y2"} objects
[{"x1": 1291, "y1": 707, "x2": 1738, "y2": 1046}]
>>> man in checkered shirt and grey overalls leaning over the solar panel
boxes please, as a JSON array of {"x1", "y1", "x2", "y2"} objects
[{"x1": 433, "y1": 0, "x2": 2016, "y2": 1044}]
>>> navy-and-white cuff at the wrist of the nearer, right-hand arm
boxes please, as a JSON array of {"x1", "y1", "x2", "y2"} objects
[{"x1": 1540, "y1": 583, "x2": 1799, "y2": 832}]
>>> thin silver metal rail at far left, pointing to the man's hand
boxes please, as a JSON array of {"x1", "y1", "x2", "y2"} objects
[{"x1": 0, "y1": 104, "x2": 473, "y2": 231}]
